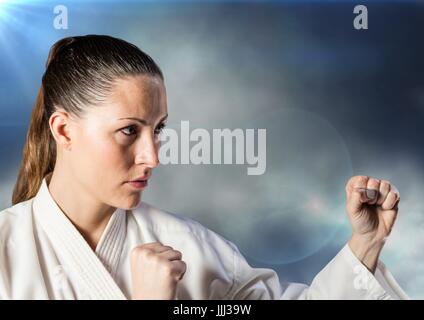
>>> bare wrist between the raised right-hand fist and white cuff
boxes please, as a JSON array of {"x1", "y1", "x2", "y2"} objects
[{"x1": 348, "y1": 234, "x2": 384, "y2": 274}]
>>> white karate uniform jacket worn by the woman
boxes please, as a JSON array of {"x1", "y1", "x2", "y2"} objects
[{"x1": 0, "y1": 178, "x2": 407, "y2": 299}]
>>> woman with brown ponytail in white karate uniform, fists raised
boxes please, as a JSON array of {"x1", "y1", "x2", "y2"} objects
[{"x1": 0, "y1": 35, "x2": 406, "y2": 299}]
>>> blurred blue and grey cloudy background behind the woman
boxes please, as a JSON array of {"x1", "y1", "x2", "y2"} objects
[{"x1": 0, "y1": 0, "x2": 424, "y2": 298}]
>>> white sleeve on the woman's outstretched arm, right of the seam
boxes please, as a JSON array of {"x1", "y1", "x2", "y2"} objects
[{"x1": 225, "y1": 243, "x2": 408, "y2": 300}]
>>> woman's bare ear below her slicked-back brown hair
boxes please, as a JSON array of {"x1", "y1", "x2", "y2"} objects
[{"x1": 49, "y1": 110, "x2": 72, "y2": 150}]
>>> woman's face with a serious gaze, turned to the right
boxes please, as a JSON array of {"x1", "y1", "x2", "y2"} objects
[{"x1": 62, "y1": 75, "x2": 167, "y2": 209}]
